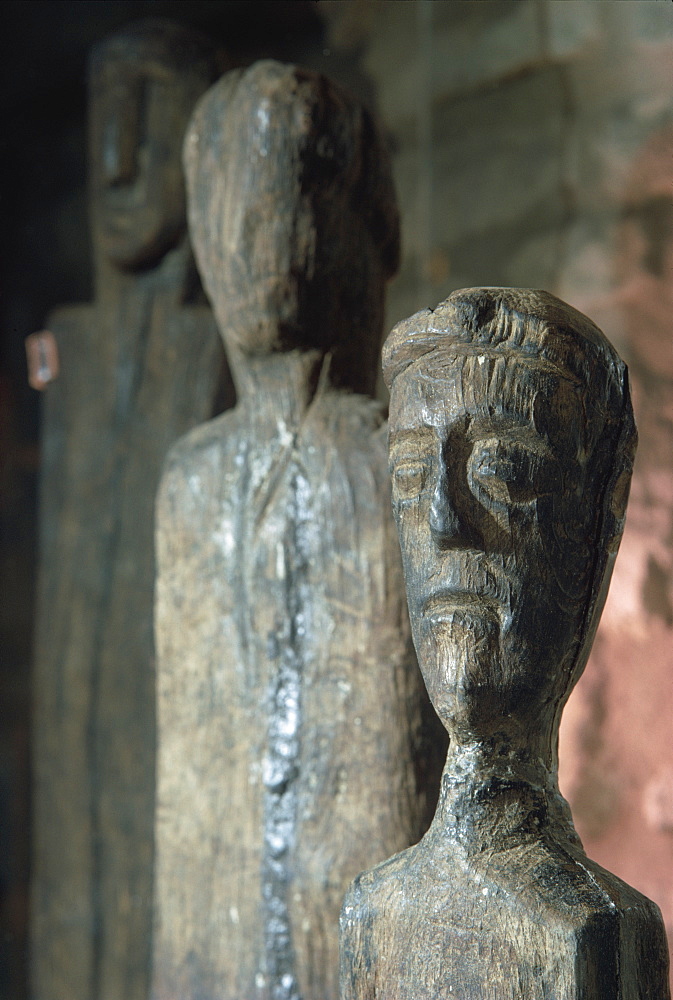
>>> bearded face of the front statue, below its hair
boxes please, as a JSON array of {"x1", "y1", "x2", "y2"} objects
[{"x1": 390, "y1": 355, "x2": 596, "y2": 735}]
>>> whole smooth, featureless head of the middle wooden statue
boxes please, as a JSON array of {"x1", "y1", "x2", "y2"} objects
[{"x1": 184, "y1": 61, "x2": 399, "y2": 382}]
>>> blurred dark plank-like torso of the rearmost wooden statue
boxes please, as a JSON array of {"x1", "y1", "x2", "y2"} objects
[{"x1": 32, "y1": 292, "x2": 222, "y2": 1000}]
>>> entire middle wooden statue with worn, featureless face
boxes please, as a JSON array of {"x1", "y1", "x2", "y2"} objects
[{"x1": 153, "y1": 62, "x2": 441, "y2": 1000}]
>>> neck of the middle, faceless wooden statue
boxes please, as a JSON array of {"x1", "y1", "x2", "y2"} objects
[{"x1": 227, "y1": 346, "x2": 329, "y2": 431}]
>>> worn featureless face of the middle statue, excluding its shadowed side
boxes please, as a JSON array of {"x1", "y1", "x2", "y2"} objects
[{"x1": 185, "y1": 78, "x2": 385, "y2": 355}]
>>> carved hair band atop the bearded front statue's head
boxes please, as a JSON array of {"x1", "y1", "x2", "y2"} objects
[{"x1": 383, "y1": 287, "x2": 625, "y2": 388}]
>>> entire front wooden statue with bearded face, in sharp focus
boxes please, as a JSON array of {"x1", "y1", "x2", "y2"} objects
[{"x1": 341, "y1": 288, "x2": 669, "y2": 1000}]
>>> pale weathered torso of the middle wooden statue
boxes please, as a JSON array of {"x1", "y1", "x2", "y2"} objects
[{"x1": 155, "y1": 393, "x2": 434, "y2": 1000}]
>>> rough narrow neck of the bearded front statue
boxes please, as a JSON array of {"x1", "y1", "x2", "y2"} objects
[{"x1": 428, "y1": 734, "x2": 581, "y2": 858}]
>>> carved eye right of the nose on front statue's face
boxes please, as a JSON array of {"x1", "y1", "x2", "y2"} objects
[{"x1": 471, "y1": 443, "x2": 556, "y2": 504}]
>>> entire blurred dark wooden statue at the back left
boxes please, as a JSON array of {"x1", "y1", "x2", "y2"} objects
[{"x1": 31, "y1": 21, "x2": 228, "y2": 1000}]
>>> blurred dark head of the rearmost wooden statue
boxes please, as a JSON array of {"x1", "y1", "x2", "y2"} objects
[{"x1": 89, "y1": 18, "x2": 217, "y2": 271}]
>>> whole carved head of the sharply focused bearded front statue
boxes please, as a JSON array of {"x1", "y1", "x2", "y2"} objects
[{"x1": 383, "y1": 288, "x2": 636, "y2": 738}]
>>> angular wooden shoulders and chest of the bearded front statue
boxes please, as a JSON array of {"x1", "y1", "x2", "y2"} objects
[{"x1": 341, "y1": 834, "x2": 668, "y2": 1000}]
